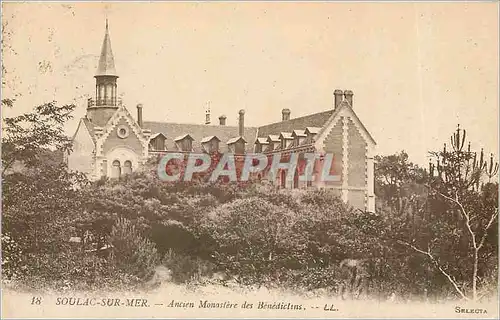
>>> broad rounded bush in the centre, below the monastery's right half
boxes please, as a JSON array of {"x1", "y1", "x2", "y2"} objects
[{"x1": 193, "y1": 187, "x2": 354, "y2": 287}]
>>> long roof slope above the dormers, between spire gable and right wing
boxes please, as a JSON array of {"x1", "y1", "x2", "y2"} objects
[{"x1": 143, "y1": 121, "x2": 257, "y2": 152}]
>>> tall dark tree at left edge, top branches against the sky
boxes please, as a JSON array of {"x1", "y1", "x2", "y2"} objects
[{"x1": 2, "y1": 102, "x2": 94, "y2": 283}]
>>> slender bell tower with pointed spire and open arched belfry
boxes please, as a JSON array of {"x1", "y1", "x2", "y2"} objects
[{"x1": 87, "y1": 19, "x2": 121, "y2": 127}]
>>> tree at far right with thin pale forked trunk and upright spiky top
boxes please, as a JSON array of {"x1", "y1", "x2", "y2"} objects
[{"x1": 397, "y1": 127, "x2": 498, "y2": 300}]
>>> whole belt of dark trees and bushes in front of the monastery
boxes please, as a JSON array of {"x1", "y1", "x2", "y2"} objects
[{"x1": 2, "y1": 99, "x2": 498, "y2": 299}]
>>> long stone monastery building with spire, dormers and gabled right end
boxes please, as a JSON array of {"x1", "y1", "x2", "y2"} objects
[{"x1": 67, "y1": 23, "x2": 376, "y2": 212}]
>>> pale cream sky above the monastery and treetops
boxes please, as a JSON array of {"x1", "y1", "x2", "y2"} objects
[{"x1": 2, "y1": 2, "x2": 499, "y2": 163}]
